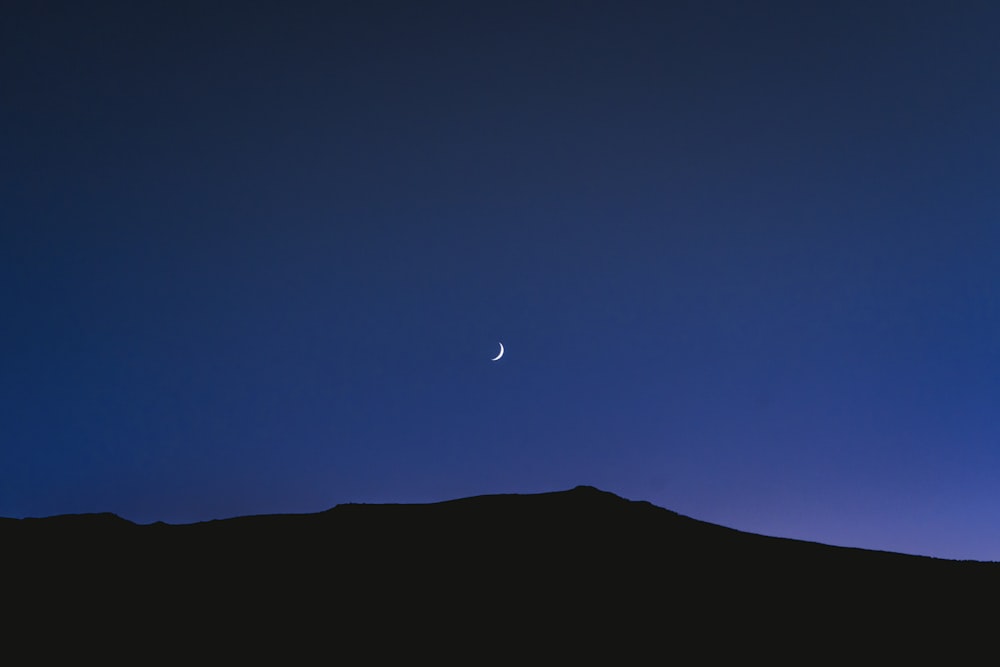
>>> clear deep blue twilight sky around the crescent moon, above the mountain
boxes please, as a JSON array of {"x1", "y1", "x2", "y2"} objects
[{"x1": 0, "y1": 0, "x2": 1000, "y2": 560}]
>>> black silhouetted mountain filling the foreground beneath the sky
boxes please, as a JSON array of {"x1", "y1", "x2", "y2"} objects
[{"x1": 0, "y1": 487, "x2": 1000, "y2": 664}]
